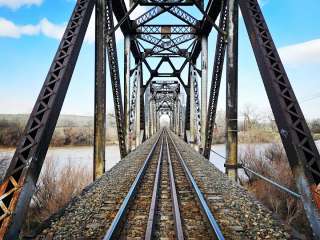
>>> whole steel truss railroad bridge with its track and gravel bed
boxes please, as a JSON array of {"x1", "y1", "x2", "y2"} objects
[{"x1": 0, "y1": 0, "x2": 320, "y2": 239}]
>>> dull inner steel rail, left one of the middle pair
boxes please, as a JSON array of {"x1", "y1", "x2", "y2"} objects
[{"x1": 144, "y1": 138, "x2": 163, "y2": 240}]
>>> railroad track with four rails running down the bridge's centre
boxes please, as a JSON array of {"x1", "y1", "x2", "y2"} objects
[{"x1": 104, "y1": 129, "x2": 224, "y2": 240}]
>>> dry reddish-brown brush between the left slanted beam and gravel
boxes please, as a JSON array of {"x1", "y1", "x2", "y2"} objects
[{"x1": 24, "y1": 159, "x2": 92, "y2": 233}]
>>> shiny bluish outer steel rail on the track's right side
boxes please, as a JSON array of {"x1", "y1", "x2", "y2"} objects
[{"x1": 168, "y1": 130, "x2": 224, "y2": 240}]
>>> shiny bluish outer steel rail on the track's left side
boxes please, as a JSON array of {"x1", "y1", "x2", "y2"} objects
[{"x1": 103, "y1": 131, "x2": 164, "y2": 240}]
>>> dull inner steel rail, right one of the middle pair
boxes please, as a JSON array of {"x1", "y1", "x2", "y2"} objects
[{"x1": 166, "y1": 134, "x2": 184, "y2": 240}]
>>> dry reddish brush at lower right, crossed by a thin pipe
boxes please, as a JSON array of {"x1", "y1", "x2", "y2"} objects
[{"x1": 240, "y1": 144, "x2": 311, "y2": 236}]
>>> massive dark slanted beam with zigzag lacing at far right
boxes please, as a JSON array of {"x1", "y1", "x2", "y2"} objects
[{"x1": 239, "y1": 0, "x2": 320, "y2": 235}]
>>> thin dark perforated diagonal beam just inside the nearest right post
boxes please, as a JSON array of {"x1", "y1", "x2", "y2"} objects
[{"x1": 203, "y1": 1, "x2": 228, "y2": 159}]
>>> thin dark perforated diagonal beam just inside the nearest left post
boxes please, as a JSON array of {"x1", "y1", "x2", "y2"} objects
[{"x1": 106, "y1": 1, "x2": 127, "y2": 158}]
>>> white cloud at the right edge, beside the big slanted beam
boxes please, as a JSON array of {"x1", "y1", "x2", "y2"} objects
[{"x1": 279, "y1": 39, "x2": 320, "y2": 65}]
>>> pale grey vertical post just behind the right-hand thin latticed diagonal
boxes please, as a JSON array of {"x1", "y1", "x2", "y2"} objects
[{"x1": 199, "y1": 36, "x2": 208, "y2": 152}]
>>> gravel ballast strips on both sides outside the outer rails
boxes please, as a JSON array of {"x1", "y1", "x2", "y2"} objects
[{"x1": 37, "y1": 134, "x2": 290, "y2": 239}]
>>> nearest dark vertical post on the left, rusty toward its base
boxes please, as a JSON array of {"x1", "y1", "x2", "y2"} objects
[{"x1": 93, "y1": 0, "x2": 106, "y2": 180}]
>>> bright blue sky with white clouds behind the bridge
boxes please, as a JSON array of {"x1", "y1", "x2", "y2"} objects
[{"x1": 0, "y1": 0, "x2": 320, "y2": 119}]
